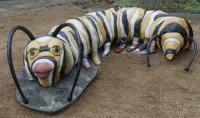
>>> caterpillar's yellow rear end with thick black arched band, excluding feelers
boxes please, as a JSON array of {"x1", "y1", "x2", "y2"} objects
[{"x1": 151, "y1": 16, "x2": 193, "y2": 60}]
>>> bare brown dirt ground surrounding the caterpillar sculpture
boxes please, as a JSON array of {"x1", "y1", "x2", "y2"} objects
[{"x1": 0, "y1": 4, "x2": 200, "y2": 118}]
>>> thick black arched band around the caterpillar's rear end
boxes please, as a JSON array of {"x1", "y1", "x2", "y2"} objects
[{"x1": 160, "y1": 23, "x2": 188, "y2": 49}]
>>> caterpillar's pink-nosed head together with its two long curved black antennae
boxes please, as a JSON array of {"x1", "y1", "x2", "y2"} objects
[{"x1": 7, "y1": 23, "x2": 83, "y2": 89}]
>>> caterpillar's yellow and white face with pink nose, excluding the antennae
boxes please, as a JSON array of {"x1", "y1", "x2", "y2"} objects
[{"x1": 24, "y1": 36, "x2": 66, "y2": 87}]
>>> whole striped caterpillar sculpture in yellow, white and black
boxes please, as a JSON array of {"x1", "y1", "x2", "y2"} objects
[{"x1": 8, "y1": 7, "x2": 197, "y2": 103}]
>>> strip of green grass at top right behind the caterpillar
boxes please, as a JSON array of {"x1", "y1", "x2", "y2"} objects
[{"x1": 115, "y1": 0, "x2": 200, "y2": 13}]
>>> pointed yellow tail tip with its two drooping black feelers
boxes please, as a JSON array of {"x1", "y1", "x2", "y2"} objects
[{"x1": 146, "y1": 30, "x2": 197, "y2": 71}]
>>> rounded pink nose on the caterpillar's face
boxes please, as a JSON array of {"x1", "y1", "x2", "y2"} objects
[{"x1": 33, "y1": 62, "x2": 53, "y2": 79}]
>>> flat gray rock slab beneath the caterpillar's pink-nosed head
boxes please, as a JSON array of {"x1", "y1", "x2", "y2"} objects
[{"x1": 16, "y1": 63, "x2": 97, "y2": 113}]
